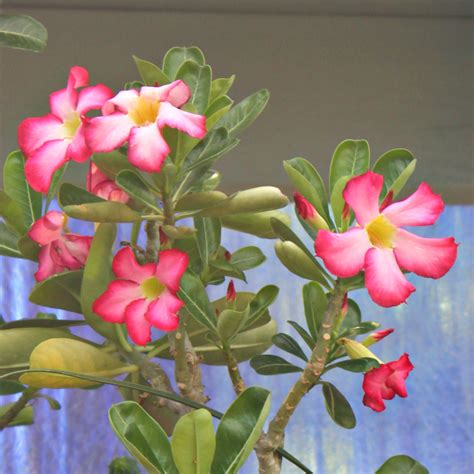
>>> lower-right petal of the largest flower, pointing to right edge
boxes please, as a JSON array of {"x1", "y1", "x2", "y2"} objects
[{"x1": 394, "y1": 229, "x2": 458, "y2": 278}]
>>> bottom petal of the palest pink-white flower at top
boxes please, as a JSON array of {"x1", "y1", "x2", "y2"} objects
[{"x1": 128, "y1": 123, "x2": 170, "y2": 173}]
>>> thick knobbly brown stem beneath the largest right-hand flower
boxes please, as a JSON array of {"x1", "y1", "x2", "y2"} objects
[{"x1": 256, "y1": 281, "x2": 346, "y2": 474}]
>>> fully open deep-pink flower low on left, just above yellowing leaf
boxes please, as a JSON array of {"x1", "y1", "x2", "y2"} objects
[{"x1": 92, "y1": 247, "x2": 189, "y2": 345}]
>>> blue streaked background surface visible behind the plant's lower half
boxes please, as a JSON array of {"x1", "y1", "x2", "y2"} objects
[{"x1": 0, "y1": 206, "x2": 474, "y2": 474}]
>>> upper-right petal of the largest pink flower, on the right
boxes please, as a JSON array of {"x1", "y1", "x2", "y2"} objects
[{"x1": 383, "y1": 183, "x2": 444, "y2": 226}]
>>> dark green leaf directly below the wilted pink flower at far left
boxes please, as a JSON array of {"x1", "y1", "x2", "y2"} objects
[{"x1": 29, "y1": 270, "x2": 82, "y2": 313}]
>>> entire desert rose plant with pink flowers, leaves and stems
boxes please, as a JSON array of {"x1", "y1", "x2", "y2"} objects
[{"x1": 0, "y1": 47, "x2": 457, "y2": 474}]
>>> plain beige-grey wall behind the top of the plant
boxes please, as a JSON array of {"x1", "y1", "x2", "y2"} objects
[{"x1": 0, "y1": 9, "x2": 474, "y2": 202}]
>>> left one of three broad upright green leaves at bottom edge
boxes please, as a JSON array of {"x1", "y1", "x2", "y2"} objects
[{"x1": 109, "y1": 401, "x2": 178, "y2": 474}]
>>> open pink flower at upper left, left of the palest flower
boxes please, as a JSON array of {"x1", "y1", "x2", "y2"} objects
[{"x1": 18, "y1": 66, "x2": 113, "y2": 193}]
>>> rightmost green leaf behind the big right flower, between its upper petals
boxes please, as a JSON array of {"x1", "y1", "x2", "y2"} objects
[{"x1": 373, "y1": 148, "x2": 416, "y2": 199}]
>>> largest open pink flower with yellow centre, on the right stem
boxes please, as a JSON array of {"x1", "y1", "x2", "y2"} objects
[{"x1": 315, "y1": 171, "x2": 457, "y2": 307}]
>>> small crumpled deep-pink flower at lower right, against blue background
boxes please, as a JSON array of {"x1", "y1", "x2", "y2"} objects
[{"x1": 362, "y1": 354, "x2": 414, "y2": 412}]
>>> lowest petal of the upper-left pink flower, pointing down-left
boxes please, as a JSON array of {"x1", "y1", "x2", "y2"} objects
[{"x1": 25, "y1": 140, "x2": 69, "y2": 193}]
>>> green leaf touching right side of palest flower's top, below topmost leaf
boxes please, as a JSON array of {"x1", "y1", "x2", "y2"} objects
[{"x1": 176, "y1": 61, "x2": 212, "y2": 115}]
